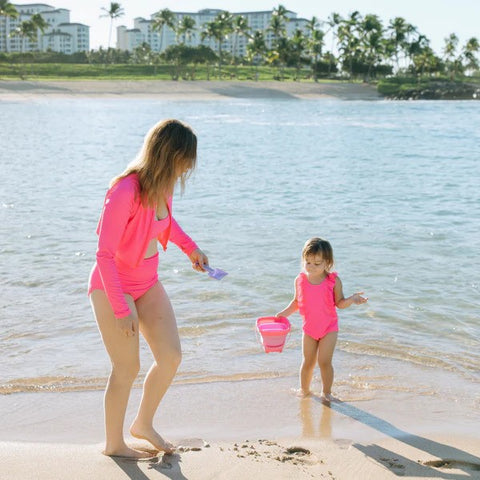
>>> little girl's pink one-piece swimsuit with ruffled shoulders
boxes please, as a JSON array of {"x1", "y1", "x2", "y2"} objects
[{"x1": 295, "y1": 272, "x2": 338, "y2": 340}]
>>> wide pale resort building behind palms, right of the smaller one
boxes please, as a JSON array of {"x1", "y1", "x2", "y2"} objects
[{"x1": 117, "y1": 9, "x2": 308, "y2": 56}]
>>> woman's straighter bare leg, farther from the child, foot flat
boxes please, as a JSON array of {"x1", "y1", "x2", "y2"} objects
[{"x1": 90, "y1": 290, "x2": 150, "y2": 458}]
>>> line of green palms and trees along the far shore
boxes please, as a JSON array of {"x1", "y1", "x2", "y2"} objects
[{"x1": 0, "y1": 0, "x2": 480, "y2": 81}]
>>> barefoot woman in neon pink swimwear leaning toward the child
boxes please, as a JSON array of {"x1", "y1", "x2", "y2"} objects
[{"x1": 88, "y1": 120, "x2": 208, "y2": 458}]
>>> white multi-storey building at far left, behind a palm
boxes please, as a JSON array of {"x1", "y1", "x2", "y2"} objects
[{"x1": 0, "y1": 3, "x2": 90, "y2": 54}]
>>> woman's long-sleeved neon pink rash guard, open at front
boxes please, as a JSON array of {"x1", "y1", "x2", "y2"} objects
[{"x1": 96, "y1": 173, "x2": 198, "y2": 318}]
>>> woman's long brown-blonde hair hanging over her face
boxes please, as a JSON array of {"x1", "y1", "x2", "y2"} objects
[{"x1": 110, "y1": 120, "x2": 197, "y2": 208}]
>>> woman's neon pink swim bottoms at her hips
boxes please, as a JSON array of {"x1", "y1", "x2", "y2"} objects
[{"x1": 88, "y1": 252, "x2": 158, "y2": 300}]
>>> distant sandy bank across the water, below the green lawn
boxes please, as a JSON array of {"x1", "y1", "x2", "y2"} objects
[{"x1": 0, "y1": 80, "x2": 381, "y2": 101}]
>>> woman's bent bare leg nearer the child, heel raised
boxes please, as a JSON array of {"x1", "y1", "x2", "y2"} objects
[{"x1": 130, "y1": 282, "x2": 182, "y2": 453}]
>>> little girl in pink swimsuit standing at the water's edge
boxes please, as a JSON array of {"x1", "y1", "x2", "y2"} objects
[{"x1": 277, "y1": 238, "x2": 368, "y2": 402}]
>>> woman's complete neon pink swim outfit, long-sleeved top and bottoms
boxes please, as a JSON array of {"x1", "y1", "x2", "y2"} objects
[{"x1": 88, "y1": 174, "x2": 198, "y2": 318}]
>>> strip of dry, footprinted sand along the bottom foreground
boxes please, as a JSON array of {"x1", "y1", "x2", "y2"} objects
[{"x1": 0, "y1": 438, "x2": 480, "y2": 480}]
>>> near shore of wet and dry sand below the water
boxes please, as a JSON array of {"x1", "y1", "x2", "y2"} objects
[{"x1": 0, "y1": 378, "x2": 480, "y2": 480}]
